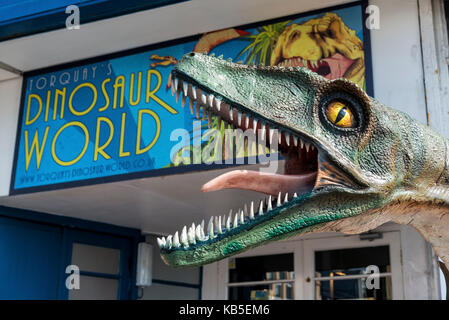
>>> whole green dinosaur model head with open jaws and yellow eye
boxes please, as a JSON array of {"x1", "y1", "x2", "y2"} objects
[{"x1": 158, "y1": 53, "x2": 449, "y2": 266}]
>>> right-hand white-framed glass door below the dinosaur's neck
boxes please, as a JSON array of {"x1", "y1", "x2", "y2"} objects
[{"x1": 304, "y1": 232, "x2": 402, "y2": 300}]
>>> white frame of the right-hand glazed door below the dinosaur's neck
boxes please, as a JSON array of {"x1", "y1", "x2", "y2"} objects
[{"x1": 302, "y1": 231, "x2": 404, "y2": 300}]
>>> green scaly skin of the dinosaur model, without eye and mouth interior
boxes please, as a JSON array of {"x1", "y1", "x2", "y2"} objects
[{"x1": 161, "y1": 53, "x2": 449, "y2": 266}]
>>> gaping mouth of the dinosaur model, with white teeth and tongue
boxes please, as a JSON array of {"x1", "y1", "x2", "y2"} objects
[{"x1": 158, "y1": 72, "x2": 321, "y2": 251}]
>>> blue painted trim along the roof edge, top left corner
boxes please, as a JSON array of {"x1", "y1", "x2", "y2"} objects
[{"x1": 0, "y1": 0, "x2": 188, "y2": 41}]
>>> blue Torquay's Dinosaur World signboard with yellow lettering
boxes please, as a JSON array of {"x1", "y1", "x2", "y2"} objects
[{"x1": 11, "y1": 3, "x2": 371, "y2": 194}]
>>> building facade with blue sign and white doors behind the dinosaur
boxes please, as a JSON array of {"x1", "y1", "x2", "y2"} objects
[{"x1": 0, "y1": 0, "x2": 449, "y2": 300}]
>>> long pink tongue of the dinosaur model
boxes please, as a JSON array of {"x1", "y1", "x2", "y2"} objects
[{"x1": 201, "y1": 170, "x2": 316, "y2": 196}]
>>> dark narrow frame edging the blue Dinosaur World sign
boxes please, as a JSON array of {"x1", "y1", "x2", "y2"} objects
[{"x1": 9, "y1": 0, "x2": 374, "y2": 195}]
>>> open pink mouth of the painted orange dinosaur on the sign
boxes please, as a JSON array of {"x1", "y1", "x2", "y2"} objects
[{"x1": 277, "y1": 53, "x2": 354, "y2": 79}]
